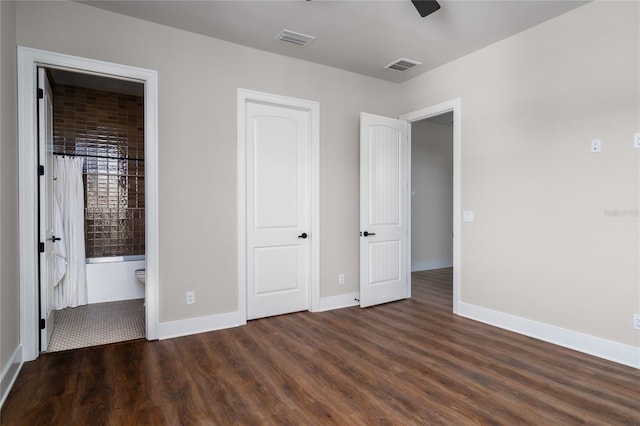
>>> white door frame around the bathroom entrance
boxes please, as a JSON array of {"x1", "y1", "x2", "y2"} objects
[{"x1": 18, "y1": 46, "x2": 159, "y2": 361}]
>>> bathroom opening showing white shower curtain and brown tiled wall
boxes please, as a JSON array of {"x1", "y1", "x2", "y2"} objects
[{"x1": 38, "y1": 67, "x2": 145, "y2": 352}]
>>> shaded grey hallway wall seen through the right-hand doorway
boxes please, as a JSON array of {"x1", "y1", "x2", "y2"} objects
[{"x1": 411, "y1": 120, "x2": 453, "y2": 271}]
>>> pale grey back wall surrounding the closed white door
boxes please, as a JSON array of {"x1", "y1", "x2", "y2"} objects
[{"x1": 17, "y1": 1, "x2": 400, "y2": 322}]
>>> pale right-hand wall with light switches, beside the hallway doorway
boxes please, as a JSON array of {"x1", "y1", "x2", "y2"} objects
[{"x1": 401, "y1": 1, "x2": 640, "y2": 348}]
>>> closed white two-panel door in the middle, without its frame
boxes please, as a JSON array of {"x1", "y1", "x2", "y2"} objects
[{"x1": 246, "y1": 102, "x2": 313, "y2": 319}]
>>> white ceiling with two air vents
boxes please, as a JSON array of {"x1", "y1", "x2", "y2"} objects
[{"x1": 80, "y1": 0, "x2": 586, "y2": 83}]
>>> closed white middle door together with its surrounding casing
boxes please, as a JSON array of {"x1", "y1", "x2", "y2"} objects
[{"x1": 237, "y1": 89, "x2": 320, "y2": 324}]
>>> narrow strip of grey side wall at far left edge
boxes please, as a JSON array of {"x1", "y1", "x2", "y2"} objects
[{"x1": 0, "y1": 1, "x2": 20, "y2": 380}]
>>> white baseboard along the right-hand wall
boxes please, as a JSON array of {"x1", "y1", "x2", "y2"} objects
[{"x1": 458, "y1": 302, "x2": 640, "y2": 369}]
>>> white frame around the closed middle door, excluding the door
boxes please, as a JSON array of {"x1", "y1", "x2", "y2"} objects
[{"x1": 237, "y1": 89, "x2": 320, "y2": 324}]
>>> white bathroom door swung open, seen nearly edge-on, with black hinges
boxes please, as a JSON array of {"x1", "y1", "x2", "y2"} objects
[{"x1": 38, "y1": 68, "x2": 57, "y2": 352}]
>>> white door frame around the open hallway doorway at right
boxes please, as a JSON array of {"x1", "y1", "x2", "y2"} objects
[{"x1": 400, "y1": 98, "x2": 462, "y2": 314}]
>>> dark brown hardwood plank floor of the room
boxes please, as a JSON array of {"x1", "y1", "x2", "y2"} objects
[{"x1": 1, "y1": 269, "x2": 640, "y2": 425}]
